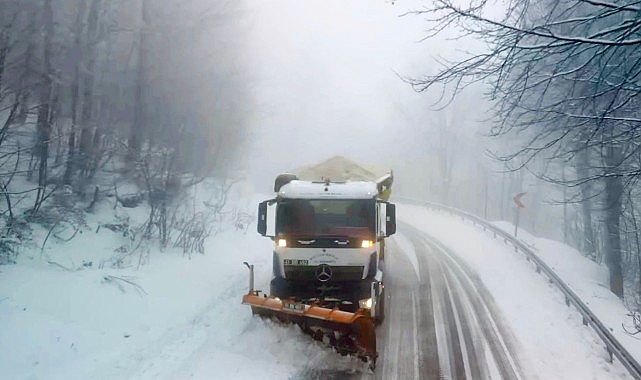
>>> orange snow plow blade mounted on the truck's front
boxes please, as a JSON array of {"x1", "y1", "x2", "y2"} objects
[{"x1": 243, "y1": 291, "x2": 378, "y2": 369}]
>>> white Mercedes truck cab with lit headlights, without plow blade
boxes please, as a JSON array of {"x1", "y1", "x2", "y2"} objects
[{"x1": 258, "y1": 174, "x2": 396, "y2": 319}]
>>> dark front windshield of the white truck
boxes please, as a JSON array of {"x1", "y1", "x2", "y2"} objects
[{"x1": 276, "y1": 199, "x2": 376, "y2": 238}]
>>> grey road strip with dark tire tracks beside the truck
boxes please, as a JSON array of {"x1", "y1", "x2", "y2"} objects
[{"x1": 404, "y1": 226, "x2": 522, "y2": 380}]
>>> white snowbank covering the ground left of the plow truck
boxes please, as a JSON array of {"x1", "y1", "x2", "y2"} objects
[{"x1": 0, "y1": 189, "x2": 309, "y2": 379}]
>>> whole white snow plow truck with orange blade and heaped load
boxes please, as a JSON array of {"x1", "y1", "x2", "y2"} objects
[{"x1": 243, "y1": 157, "x2": 396, "y2": 370}]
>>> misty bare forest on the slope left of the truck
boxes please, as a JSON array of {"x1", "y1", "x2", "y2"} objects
[{"x1": 0, "y1": 0, "x2": 246, "y2": 263}]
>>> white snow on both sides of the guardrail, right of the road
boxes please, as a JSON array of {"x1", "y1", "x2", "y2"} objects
[{"x1": 397, "y1": 205, "x2": 639, "y2": 379}]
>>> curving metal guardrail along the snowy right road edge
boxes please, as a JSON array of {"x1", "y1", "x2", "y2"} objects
[{"x1": 395, "y1": 197, "x2": 641, "y2": 379}]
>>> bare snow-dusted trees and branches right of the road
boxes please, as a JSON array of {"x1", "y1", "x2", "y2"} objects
[{"x1": 412, "y1": 0, "x2": 641, "y2": 309}]
